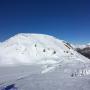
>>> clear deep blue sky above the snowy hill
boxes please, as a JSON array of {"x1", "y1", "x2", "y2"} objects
[{"x1": 0, "y1": 0, "x2": 90, "y2": 43}]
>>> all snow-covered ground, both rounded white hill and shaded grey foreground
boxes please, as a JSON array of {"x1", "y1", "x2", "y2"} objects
[{"x1": 0, "y1": 33, "x2": 90, "y2": 90}]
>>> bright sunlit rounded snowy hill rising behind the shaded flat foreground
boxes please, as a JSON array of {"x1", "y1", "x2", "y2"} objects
[{"x1": 0, "y1": 33, "x2": 88, "y2": 65}]
